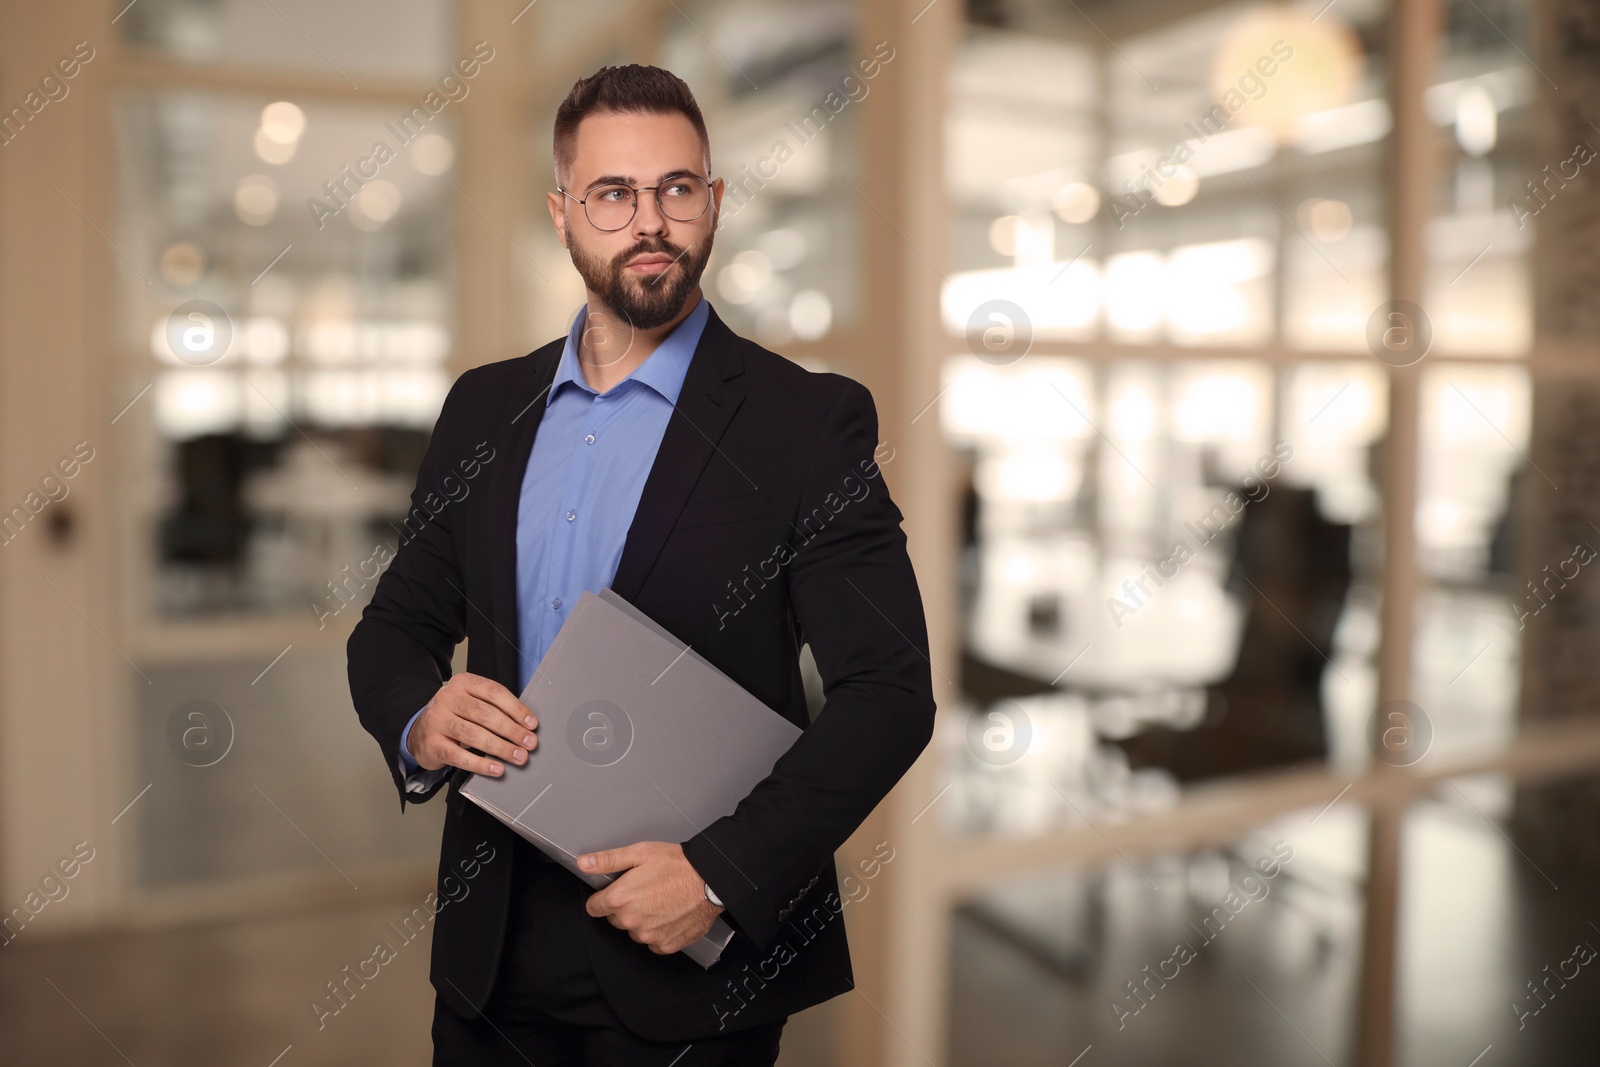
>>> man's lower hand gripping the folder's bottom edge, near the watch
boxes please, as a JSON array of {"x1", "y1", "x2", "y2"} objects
[{"x1": 578, "y1": 841, "x2": 722, "y2": 955}]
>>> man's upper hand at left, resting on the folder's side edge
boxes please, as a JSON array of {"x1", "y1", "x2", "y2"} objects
[{"x1": 406, "y1": 673, "x2": 539, "y2": 776}]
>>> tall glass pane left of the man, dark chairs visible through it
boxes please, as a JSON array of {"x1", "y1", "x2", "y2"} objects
[{"x1": 117, "y1": 91, "x2": 454, "y2": 625}]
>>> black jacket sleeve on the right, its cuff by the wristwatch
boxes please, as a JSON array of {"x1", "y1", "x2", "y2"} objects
[{"x1": 683, "y1": 376, "x2": 934, "y2": 950}]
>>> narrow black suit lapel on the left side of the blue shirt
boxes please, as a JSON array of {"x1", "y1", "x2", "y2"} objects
[{"x1": 488, "y1": 338, "x2": 566, "y2": 693}]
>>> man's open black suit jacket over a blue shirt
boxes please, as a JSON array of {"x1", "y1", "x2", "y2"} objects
[{"x1": 347, "y1": 302, "x2": 934, "y2": 1041}]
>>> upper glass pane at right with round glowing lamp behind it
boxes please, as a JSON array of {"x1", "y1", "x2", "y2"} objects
[{"x1": 944, "y1": 3, "x2": 1390, "y2": 352}]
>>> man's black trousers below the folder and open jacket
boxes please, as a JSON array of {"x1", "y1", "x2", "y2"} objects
[{"x1": 434, "y1": 841, "x2": 784, "y2": 1067}]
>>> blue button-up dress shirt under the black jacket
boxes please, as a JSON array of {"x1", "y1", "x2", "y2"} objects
[{"x1": 400, "y1": 298, "x2": 710, "y2": 792}]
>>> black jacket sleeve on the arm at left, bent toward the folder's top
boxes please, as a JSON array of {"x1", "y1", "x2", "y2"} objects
[{"x1": 346, "y1": 371, "x2": 478, "y2": 811}]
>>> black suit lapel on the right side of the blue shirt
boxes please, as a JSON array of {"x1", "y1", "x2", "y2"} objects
[{"x1": 611, "y1": 298, "x2": 754, "y2": 600}]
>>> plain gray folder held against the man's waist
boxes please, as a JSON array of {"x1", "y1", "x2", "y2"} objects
[{"x1": 461, "y1": 589, "x2": 800, "y2": 968}]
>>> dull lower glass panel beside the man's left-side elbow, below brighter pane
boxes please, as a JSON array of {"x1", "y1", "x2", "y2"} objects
[{"x1": 126, "y1": 645, "x2": 445, "y2": 893}]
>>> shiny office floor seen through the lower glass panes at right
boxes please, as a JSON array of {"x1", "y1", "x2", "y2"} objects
[{"x1": 950, "y1": 789, "x2": 1600, "y2": 1067}]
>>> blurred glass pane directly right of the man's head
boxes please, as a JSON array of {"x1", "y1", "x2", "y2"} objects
[{"x1": 661, "y1": 0, "x2": 864, "y2": 346}]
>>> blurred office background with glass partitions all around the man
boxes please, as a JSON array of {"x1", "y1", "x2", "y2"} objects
[{"x1": 0, "y1": 0, "x2": 1600, "y2": 1067}]
